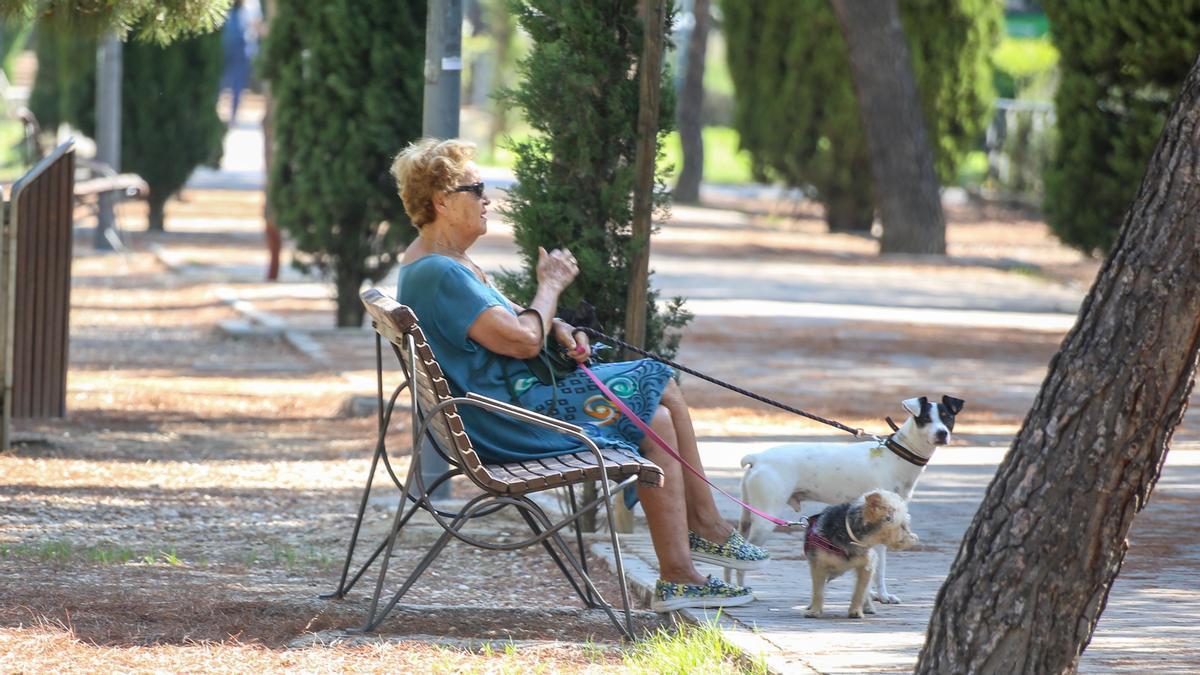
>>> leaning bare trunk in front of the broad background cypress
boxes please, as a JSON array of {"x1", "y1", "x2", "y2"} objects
[{"x1": 832, "y1": 0, "x2": 946, "y2": 255}]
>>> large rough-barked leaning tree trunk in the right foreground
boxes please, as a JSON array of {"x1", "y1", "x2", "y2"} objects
[{"x1": 917, "y1": 53, "x2": 1200, "y2": 673}]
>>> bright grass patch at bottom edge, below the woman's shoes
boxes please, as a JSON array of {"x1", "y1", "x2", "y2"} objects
[{"x1": 624, "y1": 622, "x2": 767, "y2": 675}]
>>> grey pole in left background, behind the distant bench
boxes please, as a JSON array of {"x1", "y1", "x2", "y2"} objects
[{"x1": 92, "y1": 35, "x2": 121, "y2": 251}]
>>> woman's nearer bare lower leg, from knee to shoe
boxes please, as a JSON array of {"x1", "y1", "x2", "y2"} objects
[{"x1": 637, "y1": 406, "x2": 704, "y2": 584}]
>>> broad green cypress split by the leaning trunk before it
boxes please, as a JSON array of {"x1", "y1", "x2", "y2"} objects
[{"x1": 722, "y1": 0, "x2": 1001, "y2": 231}]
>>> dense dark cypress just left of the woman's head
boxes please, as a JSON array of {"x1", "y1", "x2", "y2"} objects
[{"x1": 262, "y1": 0, "x2": 426, "y2": 325}]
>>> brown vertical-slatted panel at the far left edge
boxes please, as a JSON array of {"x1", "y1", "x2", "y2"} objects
[{"x1": 0, "y1": 141, "x2": 74, "y2": 448}]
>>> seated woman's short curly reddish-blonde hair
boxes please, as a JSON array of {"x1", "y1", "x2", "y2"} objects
[{"x1": 391, "y1": 138, "x2": 475, "y2": 229}]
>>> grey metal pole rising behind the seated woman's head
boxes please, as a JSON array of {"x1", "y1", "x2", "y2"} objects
[{"x1": 420, "y1": 0, "x2": 462, "y2": 500}]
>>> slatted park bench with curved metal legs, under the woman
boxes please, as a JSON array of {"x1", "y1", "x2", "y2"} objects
[{"x1": 325, "y1": 288, "x2": 664, "y2": 638}]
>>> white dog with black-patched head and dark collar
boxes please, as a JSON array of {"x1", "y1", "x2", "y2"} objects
[{"x1": 726, "y1": 396, "x2": 964, "y2": 604}]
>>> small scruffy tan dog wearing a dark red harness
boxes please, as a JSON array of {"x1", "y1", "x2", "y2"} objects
[{"x1": 804, "y1": 490, "x2": 917, "y2": 619}]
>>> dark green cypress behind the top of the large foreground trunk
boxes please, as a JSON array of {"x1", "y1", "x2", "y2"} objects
[{"x1": 1042, "y1": 0, "x2": 1200, "y2": 252}]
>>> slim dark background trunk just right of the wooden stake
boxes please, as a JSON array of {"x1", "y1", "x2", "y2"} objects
[{"x1": 672, "y1": 0, "x2": 712, "y2": 204}]
